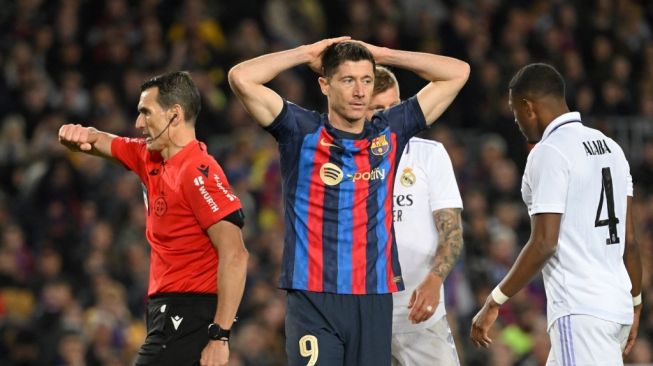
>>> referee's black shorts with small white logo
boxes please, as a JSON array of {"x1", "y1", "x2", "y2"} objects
[{"x1": 135, "y1": 293, "x2": 217, "y2": 366}]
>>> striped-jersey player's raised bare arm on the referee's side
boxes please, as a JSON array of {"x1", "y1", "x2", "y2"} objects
[{"x1": 229, "y1": 37, "x2": 349, "y2": 127}]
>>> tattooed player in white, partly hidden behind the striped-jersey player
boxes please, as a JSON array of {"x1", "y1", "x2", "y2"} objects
[{"x1": 367, "y1": 66, "x2": 463, "y2": 366}]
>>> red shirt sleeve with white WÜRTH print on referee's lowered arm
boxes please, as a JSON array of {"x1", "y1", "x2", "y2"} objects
[{"x1": 181, "y1": 159, "x2": 241, "y2": 230}]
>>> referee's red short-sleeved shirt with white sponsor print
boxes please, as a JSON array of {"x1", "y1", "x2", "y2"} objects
[{"x1": 111, "y1": 137, "x2": 241, "y2": 296}]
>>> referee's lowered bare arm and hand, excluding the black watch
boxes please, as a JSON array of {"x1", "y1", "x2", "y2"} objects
[{"x1": 200, "y1": 220, "x2": 249, "y2": 366}]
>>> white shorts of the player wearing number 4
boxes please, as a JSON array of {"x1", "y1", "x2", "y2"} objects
[{"x1": 546, "y1": 315, "x2": 631, "y2": 366}]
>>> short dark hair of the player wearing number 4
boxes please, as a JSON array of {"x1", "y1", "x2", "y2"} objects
[{"x1": 508, "y1": 63, "x2": 565, "y2": 99}]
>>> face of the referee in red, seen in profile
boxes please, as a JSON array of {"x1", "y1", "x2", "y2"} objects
[{"x1": 136, "y1": 88, "x2": 168, "y2": 151}]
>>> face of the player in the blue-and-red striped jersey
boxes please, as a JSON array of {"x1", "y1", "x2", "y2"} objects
[{"x1": 320, "y1": 60, "x2": 374, "y2": 123}]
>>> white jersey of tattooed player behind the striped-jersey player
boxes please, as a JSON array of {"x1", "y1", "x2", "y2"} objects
[{"x1": 392, "y1": 137, "x2": 463, "y2": 332}]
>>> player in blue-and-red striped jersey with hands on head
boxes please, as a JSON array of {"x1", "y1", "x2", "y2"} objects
[{"x1": 229, "y1": 37, "x2": 469, "y2": 366}]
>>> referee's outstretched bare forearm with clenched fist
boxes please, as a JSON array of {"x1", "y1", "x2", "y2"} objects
[{"x1": 59, "y1": 124, "x2": 116, "y2": 159}]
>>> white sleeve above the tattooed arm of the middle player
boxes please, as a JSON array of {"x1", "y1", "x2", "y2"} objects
[{"x1": 424, "y1": 145, "x2": 463, "y2": 211}]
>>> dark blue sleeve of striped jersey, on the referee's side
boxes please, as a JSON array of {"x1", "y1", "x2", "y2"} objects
[{"x1": 264, "y1": 100, "x2": 320, "y2": 144}]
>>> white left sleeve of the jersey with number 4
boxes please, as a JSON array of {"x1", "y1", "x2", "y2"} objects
[{"x1": 528, "y1": 145, "x2": 571, "y2": 215}]
